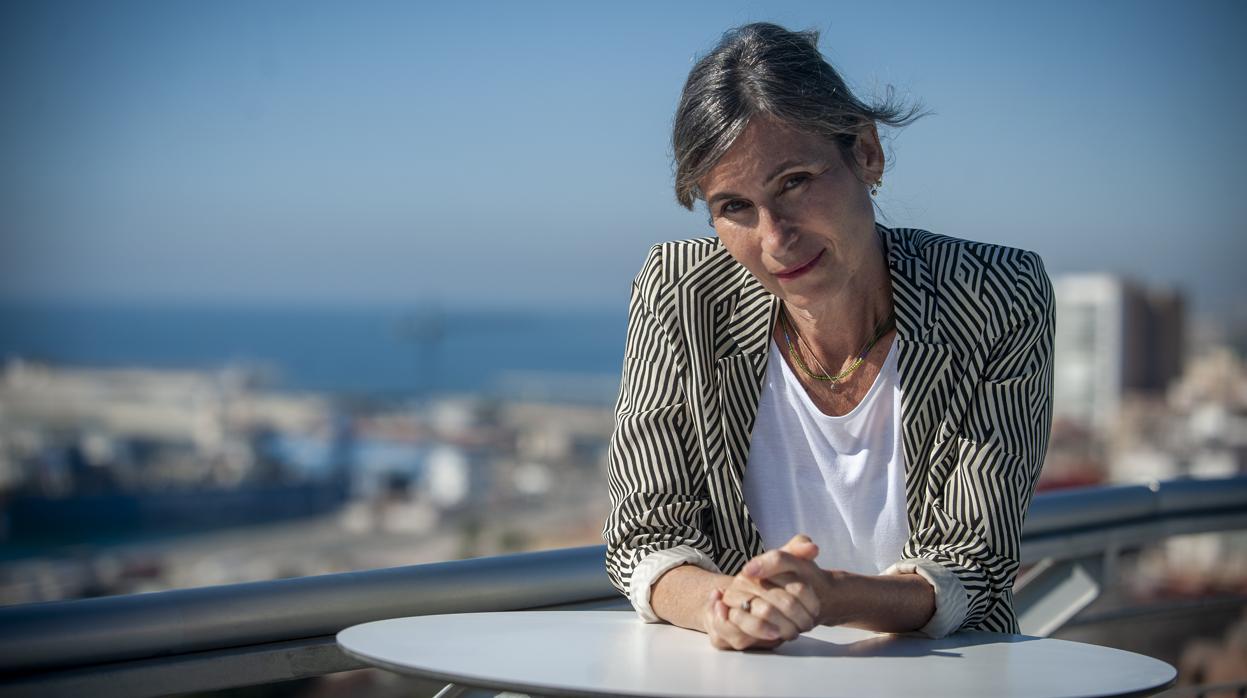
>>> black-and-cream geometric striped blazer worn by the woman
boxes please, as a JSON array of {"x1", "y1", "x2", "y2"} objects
[{"x1": 604, "y1": 226, "x2": 1054, "y2": 632}]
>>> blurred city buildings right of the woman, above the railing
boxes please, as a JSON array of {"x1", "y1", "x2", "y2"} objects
[{"x1": 1041, "y1": 273, "x2": 1247, "y2": 486}]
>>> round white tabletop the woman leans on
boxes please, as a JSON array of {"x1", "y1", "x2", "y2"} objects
[{"x1": 338, "y1": 611, "x2": 1176, "y2": 698}]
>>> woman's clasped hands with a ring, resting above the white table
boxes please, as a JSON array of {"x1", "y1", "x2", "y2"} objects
[{"x1": 702, "y1": 535, "x2": 828, "y2": 649}]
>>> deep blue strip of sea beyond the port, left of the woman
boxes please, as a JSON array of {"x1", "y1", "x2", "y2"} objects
[{"x1": 0, "y1": 303, "x2": 627, "y2": 403}]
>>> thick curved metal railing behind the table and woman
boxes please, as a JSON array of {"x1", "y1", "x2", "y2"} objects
[{"x1": 0, "y1": 476, "x2": 1247, "y2": 697}]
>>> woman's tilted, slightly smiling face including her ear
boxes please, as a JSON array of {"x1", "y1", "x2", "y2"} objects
[{"x1": 698, "y1": 118, "x2": 883, "y2": 308}]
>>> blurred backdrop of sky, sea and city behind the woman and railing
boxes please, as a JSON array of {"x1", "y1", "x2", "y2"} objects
[{"x1": 0, "y1": 0, "x2": 1247, "y2": 694}]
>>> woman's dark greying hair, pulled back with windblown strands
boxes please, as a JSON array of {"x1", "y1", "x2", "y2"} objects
[{"x1": 671, "y1": 22, "x2": 923, "y2": 208}]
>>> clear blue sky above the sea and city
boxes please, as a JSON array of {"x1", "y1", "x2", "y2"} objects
[{"x1": 0, "y1": 0, "x2": 1247, "y2": 317}]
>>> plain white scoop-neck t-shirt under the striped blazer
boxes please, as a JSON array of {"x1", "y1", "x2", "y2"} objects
[{"x1": 744, "y1": 342, "x2": 909, "y2": 575}]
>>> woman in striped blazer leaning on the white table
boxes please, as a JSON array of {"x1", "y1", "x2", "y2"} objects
[{"x1": 604, "y1": 24, "x2": 1052, "y2": 649}]
